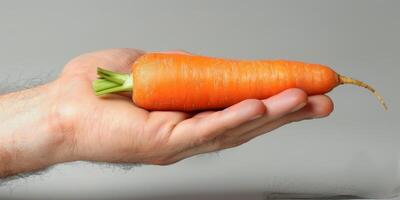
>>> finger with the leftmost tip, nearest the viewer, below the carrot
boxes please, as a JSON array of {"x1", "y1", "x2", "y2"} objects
[{"x1": 171, "y1": 99, "x2": 265, "y2": 147}]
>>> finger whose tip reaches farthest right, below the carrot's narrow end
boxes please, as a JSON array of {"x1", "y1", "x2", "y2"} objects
[{"x1": 239, "y1": 95, "x2": 334, "y2": 142}]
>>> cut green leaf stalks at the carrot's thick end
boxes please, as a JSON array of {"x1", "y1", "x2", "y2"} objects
[{"x1": 93, "y1": 67, "x2": 132, "y2": 96}]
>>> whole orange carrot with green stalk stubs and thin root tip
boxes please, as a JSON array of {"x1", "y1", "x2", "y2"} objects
[{"x1": 93, "y1": 53, "x2": 387, "y2": 111}]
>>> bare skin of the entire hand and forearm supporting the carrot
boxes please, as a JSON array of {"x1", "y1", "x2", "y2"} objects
[{"x1": 0, "y1": 49, "x2": 333, "y2": 177}]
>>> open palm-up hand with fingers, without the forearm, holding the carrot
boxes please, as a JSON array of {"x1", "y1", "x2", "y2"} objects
[{"x1": 52, "y1": 49, "x2": 333, "y2": 165}]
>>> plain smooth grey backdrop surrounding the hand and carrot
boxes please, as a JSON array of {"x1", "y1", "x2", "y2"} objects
[{"x1": 0, "y1": 0, "x2": 400, "y2": 199}]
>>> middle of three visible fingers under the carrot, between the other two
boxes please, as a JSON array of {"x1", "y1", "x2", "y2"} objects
[{"x1": 229, "y1": 89, "x2": 308, "y2": 137}]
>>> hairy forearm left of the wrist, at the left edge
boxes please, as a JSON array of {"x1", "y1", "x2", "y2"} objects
[{"x1": 0, "y1": 85, "x2": 69, "y2": 177}]
